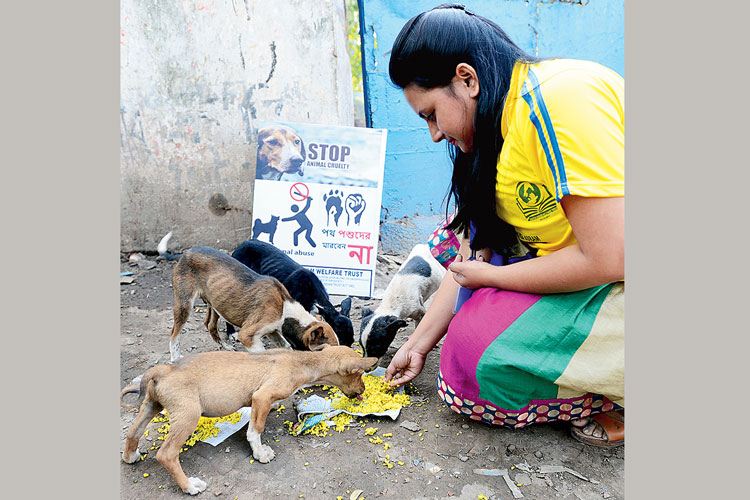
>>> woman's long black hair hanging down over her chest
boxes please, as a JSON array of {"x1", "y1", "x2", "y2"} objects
[{"x1": 388, "y1": 3, "x2": 539, "y2": 254}]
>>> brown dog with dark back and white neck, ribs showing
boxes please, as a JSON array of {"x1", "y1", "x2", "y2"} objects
[{"x1": 169, "y1": 247, "x2": 339, "y2": 361}]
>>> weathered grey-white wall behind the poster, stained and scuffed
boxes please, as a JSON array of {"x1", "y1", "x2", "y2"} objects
[{"x1": 120, "y1": 0, "x2": 354, "y2": 251}]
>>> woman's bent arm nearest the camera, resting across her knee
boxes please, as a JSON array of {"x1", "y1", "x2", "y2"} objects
[{"x1": 449, "y1": 196, "x2": 625, "y2": 293}]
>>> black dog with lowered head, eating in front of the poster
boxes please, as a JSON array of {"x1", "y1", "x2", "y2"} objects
[{"x1": 227, "y1": 239, "x2": 354, "y2": 345}]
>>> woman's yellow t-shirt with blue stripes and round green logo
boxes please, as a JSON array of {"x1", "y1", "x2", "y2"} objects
[{"x1": 496, "y1": 59, "x2": 625, "y2": 255}]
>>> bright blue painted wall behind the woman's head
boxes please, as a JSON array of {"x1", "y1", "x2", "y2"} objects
[{"x1": 360, "y1": 0, "x2": 625, "y2": 253}]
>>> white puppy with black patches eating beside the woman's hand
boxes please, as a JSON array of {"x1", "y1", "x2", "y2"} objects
[{"x1": 359, "y1": 244, "x2": 445, "y2": 358}]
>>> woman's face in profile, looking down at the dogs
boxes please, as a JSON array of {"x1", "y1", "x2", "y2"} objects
[{"x1": 404, "y1": 77, "x2": 477, "y2": 153}]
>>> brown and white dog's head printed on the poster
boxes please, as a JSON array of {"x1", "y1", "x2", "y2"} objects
[{"x1": 255, "y1": 125, "x2": 305, "y2": 181}]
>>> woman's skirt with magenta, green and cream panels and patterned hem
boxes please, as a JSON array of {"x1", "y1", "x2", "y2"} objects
[{"x1": 437, "y1": 282, "x2": 625, "y2": 428}]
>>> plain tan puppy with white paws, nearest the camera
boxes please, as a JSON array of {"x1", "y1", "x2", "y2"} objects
[{"x1": 120, "y1": 345, "x2": 378, "y2": 495}]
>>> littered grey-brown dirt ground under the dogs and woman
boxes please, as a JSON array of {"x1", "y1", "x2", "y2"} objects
[{"x1": 120, "y1": 248, "x2": 625, "y2": 500}]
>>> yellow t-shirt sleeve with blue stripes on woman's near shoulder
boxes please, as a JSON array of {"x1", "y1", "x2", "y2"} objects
[{"x1": 524, "y1": 68, "x2": 625, "y2": 201}]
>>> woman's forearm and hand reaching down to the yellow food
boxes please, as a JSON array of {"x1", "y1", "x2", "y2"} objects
[{"x1": 385, "y1": 235, "x2": 469, "y2": 386}]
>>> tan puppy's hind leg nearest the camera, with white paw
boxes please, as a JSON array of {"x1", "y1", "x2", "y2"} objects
[{"x1": 156, "y1": 403, "x2": 208, "y2": 495}]
